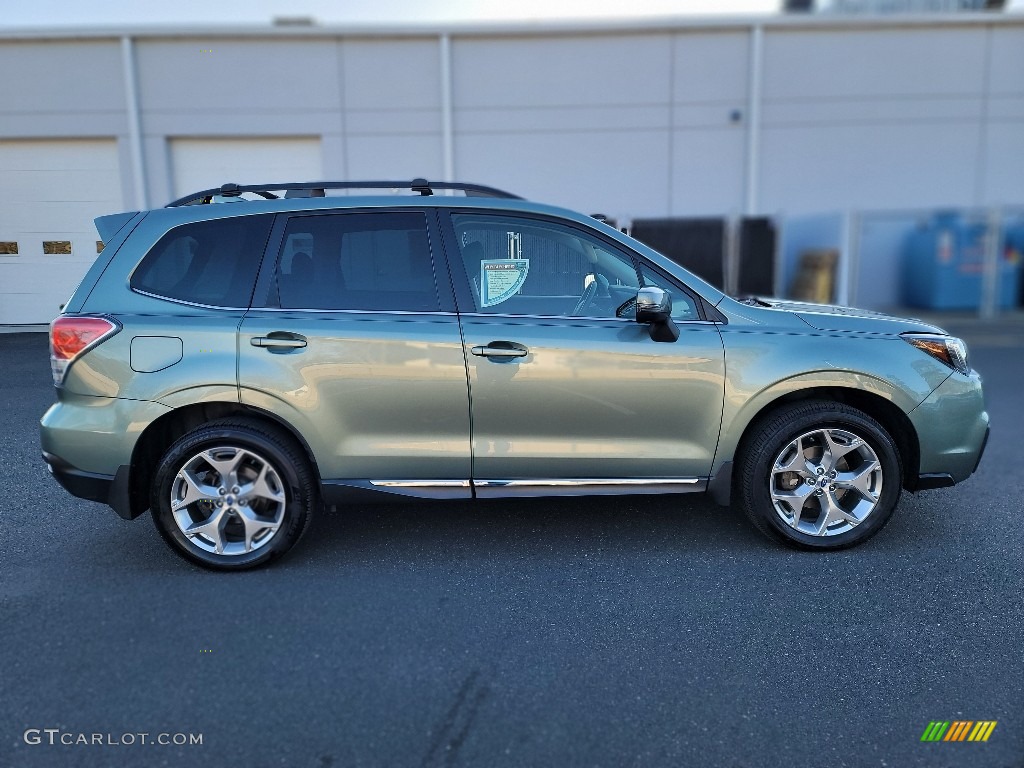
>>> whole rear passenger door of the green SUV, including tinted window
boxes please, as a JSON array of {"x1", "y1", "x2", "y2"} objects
[{"x1": 239, "y1": 208, "x2": 471, "y2": 497}]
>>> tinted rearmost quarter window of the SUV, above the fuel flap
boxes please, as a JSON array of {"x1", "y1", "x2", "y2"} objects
[{"x1": 131, "y1": 216, "x2": 273, "y2": 307}]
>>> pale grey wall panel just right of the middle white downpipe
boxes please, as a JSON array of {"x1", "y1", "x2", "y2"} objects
[{"x1": 453, "y1": 35, "x2": 672, "y2": 216}]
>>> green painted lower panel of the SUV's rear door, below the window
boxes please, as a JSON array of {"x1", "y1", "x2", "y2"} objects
[{"x1": 239, "y1": 310, "x2": 470, "y2": 481}]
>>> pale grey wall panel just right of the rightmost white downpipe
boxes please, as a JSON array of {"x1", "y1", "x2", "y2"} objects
[{"x1": 761, "y1": 28, "x2": 986, "y2": 211}]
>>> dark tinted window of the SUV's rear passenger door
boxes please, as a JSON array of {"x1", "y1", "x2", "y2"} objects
[{"x1": 278, "y1": 212, "x2": 438, "y2": 311}]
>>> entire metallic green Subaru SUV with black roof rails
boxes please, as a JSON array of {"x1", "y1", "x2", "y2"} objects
[{"x1": 42, "y1": 179, "x2": 988, "y2": 569}]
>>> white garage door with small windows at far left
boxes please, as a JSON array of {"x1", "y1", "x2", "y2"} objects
[{"x1": 0, "y1": 139, "x2": 125, "y2": 325}]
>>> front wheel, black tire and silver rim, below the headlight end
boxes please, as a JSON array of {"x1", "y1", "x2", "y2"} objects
[{"x1": 733, "y1": 400, "x2": 903, "y2": 550}]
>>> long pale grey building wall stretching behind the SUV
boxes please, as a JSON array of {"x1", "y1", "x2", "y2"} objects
[{"x1": 0, "y1": 16, "x2": 1024, "y2": 322}]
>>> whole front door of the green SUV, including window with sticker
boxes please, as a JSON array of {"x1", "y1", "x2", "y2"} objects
[{"x1": 445, "y1": 211, "x2": 725, "y2": 496}]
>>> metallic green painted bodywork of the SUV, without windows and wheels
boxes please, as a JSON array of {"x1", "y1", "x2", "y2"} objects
[{"x1": 42, "y1": 196, "x2": 988, "y2": 528}]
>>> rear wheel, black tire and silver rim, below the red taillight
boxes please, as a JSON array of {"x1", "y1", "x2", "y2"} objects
[{"x1": 150, "y1": 419, "x2": 318, "y2": 570}]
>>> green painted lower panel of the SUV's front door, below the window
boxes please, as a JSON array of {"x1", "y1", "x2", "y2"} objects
[{"x1": 463, "y1": 315, "x2": 724, "y2": 479}]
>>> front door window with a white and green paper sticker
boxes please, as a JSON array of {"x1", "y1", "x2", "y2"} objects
[{"x1": 452, "y1": 213, "x2": 697, "y2": 319}]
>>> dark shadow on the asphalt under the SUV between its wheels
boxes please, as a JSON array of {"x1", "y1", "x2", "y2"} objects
[{"x1": 287, "y1": 496, "x2": 773, "y2": 561}]
